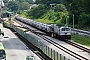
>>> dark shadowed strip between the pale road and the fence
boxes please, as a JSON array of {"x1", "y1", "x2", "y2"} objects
[{"x1": 9, "y1": 20, "x2": 52, "y2": 60}]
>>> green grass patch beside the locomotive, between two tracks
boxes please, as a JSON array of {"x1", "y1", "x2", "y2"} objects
[{"x1": 71, "y1": 34, "x2": 90, "y2": 48}]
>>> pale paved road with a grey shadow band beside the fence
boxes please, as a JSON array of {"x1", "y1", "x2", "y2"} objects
[{"x1": 0, "y1": 20, "x2": 41, "y2": 60}]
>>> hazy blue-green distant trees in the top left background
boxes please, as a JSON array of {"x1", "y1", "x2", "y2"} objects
[{"x1": 4, "y1": 0, "x2": 34, "y2": 13}]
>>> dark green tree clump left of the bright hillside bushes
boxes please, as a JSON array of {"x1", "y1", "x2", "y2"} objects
[{"x1": 27, "y1": 4, "x2": 46, "y2": 18}]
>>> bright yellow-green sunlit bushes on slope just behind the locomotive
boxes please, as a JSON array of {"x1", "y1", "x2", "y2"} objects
[{"x1": 39, "y1": 9, "x2": 68, "y2": 25}]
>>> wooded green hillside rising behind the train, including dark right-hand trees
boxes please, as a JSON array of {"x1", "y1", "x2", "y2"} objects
[{"x1": 27, "y1": 0, "x2": 90, "y2": 28}]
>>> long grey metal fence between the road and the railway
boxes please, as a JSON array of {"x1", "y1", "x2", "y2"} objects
[{"x1": 5, "y1": 24, "x2": 70, "y2": 60}]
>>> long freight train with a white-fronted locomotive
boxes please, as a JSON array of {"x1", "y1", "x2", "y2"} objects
[{"x1": 14, "y1": 15, "x2": 71, "y2": 41}]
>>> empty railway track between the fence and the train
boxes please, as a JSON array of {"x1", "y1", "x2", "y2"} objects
[{"x1": 13, "y1": 19, "x2": 88, "y2": 60}]
